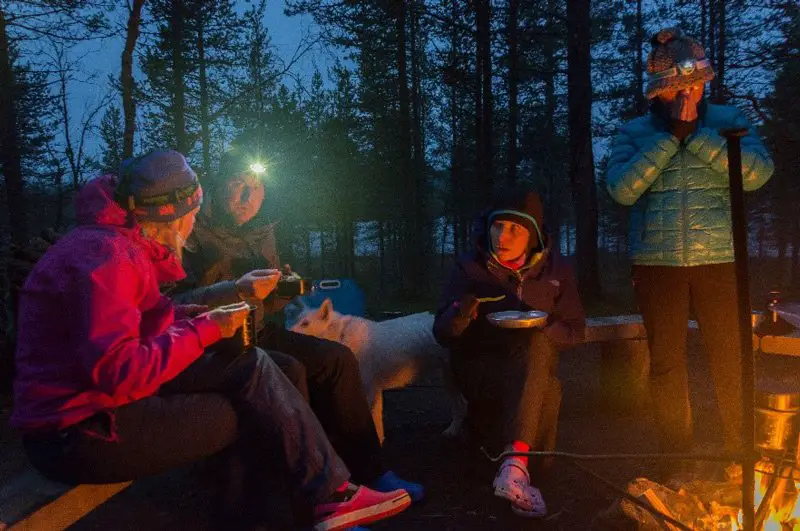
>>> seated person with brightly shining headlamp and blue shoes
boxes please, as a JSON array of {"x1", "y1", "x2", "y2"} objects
[{"x1": 169, "y1": 148, "x2": 424, "y2": 502}]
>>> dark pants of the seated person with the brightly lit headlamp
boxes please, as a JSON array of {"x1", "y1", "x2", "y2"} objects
[{"x1": 259, "y1": 325, "x2": 383, "y2": 484}]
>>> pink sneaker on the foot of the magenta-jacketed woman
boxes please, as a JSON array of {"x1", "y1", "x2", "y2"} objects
[{"x1": 314, "y1": 484, "x2": 411, "y2": 531}]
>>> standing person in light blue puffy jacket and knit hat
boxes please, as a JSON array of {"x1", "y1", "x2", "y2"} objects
[{"x1": 607, "y1": 28, "x2": 773, "y2": 478}]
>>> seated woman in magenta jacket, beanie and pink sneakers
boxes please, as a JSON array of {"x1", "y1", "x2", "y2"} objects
[{"x1": 11, "y1": 151, "x2": 410, "y2": 530}]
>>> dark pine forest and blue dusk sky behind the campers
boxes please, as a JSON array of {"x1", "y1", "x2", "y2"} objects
[{"x1": 0, "y1": 0, "x2": 800, "y2": 324}]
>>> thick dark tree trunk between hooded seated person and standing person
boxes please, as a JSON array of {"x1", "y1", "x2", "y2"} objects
[{"x1": 567, "y1": 0, "x2": 600, "y2": 294}]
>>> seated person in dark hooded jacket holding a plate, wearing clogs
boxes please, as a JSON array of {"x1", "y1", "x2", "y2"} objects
[{"x1": 434, "y1": 191, "x2": 585, "y2": 517}]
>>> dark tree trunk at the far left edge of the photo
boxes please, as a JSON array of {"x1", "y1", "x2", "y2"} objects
[{"x1": 0, "y1": 6, "x2": 28, "y2": 245}]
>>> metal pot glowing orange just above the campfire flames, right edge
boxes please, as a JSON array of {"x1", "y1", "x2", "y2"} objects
[{"x1": 755, "y1": 392, "x2": 800, "y2": 454}]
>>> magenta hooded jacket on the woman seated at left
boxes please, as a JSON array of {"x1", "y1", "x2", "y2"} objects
[{"x1": 11, "y1": 175, "x2": 221, "y2": 433}]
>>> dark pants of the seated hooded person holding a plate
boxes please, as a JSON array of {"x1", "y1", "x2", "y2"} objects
[{"x1": 451, "y1": 330, "x2": 561, "y2": 462}]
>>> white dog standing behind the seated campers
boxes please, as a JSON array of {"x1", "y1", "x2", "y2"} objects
[{"x1": 290, "y1": 299, "x2": 467, "y2": 442}]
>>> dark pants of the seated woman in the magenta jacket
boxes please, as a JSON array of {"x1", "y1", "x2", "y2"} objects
[{"x1": 24, "y1": 349, "x2": 349, "y2": 528}]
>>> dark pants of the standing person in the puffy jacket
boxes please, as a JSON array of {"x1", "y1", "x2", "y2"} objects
[{"x1": 633, "y1": 264, "x2": 742, "y2": 452}]
